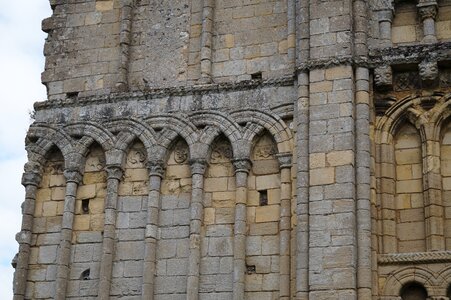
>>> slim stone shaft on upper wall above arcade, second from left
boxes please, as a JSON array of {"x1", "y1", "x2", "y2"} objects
[{"x1": 200, "y1": 0, "x2": 215, "y2": 83}]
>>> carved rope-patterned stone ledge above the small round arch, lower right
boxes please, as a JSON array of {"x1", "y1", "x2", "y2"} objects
[{"x1": 377, "y1": 251, "x2": 451, "y2": 265}]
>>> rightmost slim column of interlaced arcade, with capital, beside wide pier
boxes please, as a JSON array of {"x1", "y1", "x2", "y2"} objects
[{"x1": 277, "y1": 153, "x2": 292, "y2": 300}]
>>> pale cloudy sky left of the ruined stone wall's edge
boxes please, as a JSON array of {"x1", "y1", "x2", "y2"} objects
[{"x1": 0, "y1": 0, "x2": 51, "y2": 299}]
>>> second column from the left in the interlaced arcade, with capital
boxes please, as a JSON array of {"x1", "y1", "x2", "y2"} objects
[{"x1": 55, "y1": 169, "x2": 82, "y2": 300}]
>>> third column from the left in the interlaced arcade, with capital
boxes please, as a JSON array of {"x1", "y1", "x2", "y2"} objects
[{"x1": 98, "y1": 165, "x2": 123, "y2": 300}]
